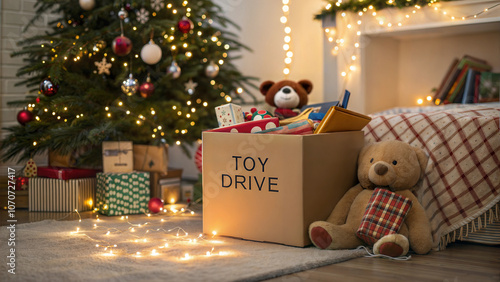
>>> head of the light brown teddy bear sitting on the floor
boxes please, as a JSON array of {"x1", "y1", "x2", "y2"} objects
[{"x1": 358, "y1": 140, "x2": 428, "y2": 191}]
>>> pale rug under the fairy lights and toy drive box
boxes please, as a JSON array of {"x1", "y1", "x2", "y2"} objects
[{"x1": 0, "y1": 214, "x2": 365, "y2": 281}]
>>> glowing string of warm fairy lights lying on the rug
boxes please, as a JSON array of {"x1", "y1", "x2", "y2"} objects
[{"x1": 65, "y1": 204, "x2": 235, "y2": 262}]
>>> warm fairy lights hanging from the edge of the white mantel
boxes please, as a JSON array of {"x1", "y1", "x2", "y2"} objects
[{"x1": 324, "y1": 0, "x2": 500, "y2": 100}]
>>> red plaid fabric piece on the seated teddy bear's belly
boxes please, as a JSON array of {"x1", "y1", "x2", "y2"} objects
[{"x1": 356, "y1": 188, "x2": 412, "y2": 245}]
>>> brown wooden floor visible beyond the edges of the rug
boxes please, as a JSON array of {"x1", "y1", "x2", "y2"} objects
[{"x1": 0, "y1": 209, "x2": 500, "y2": 282}]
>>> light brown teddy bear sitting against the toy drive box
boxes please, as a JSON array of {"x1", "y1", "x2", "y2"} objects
[{"x1": 309, "y1": 140, "x2": 432, "y2": 257}]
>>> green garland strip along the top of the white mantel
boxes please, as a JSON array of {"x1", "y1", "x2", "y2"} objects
[{"x1": 315, "y1": 0, "x2": 456, "y2": 19}]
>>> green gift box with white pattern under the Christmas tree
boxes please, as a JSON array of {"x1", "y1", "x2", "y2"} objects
[{"x1": 96, "y1": 172, "x2": 150, "y2": 215}]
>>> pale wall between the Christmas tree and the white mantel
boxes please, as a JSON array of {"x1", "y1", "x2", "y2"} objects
[{"x1": 174, "y1": 0, "x2": 324, "y2": 178}]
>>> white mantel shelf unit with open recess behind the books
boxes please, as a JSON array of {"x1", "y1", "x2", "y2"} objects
[{"x1": 325, "y1": 0, "x2": 500, "y2": 114}]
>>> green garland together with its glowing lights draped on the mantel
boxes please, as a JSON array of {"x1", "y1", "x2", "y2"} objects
[{"x1": 316, "y1": 0, "x2": 500, "y2": 105}]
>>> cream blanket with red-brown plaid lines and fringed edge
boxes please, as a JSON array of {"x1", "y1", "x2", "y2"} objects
[{"x1": 363, "y1": 103, "x2": 500, "y2": 249}]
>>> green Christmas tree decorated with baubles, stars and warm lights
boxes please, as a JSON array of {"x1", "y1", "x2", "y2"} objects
[{"x1": 1, "y1": 0, "x2": 255, "y2": 165}]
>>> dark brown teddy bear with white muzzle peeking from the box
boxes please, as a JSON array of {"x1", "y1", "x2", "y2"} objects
[{"x1": 260, "y1": 80, "x2": 312, "y2": 119}]
